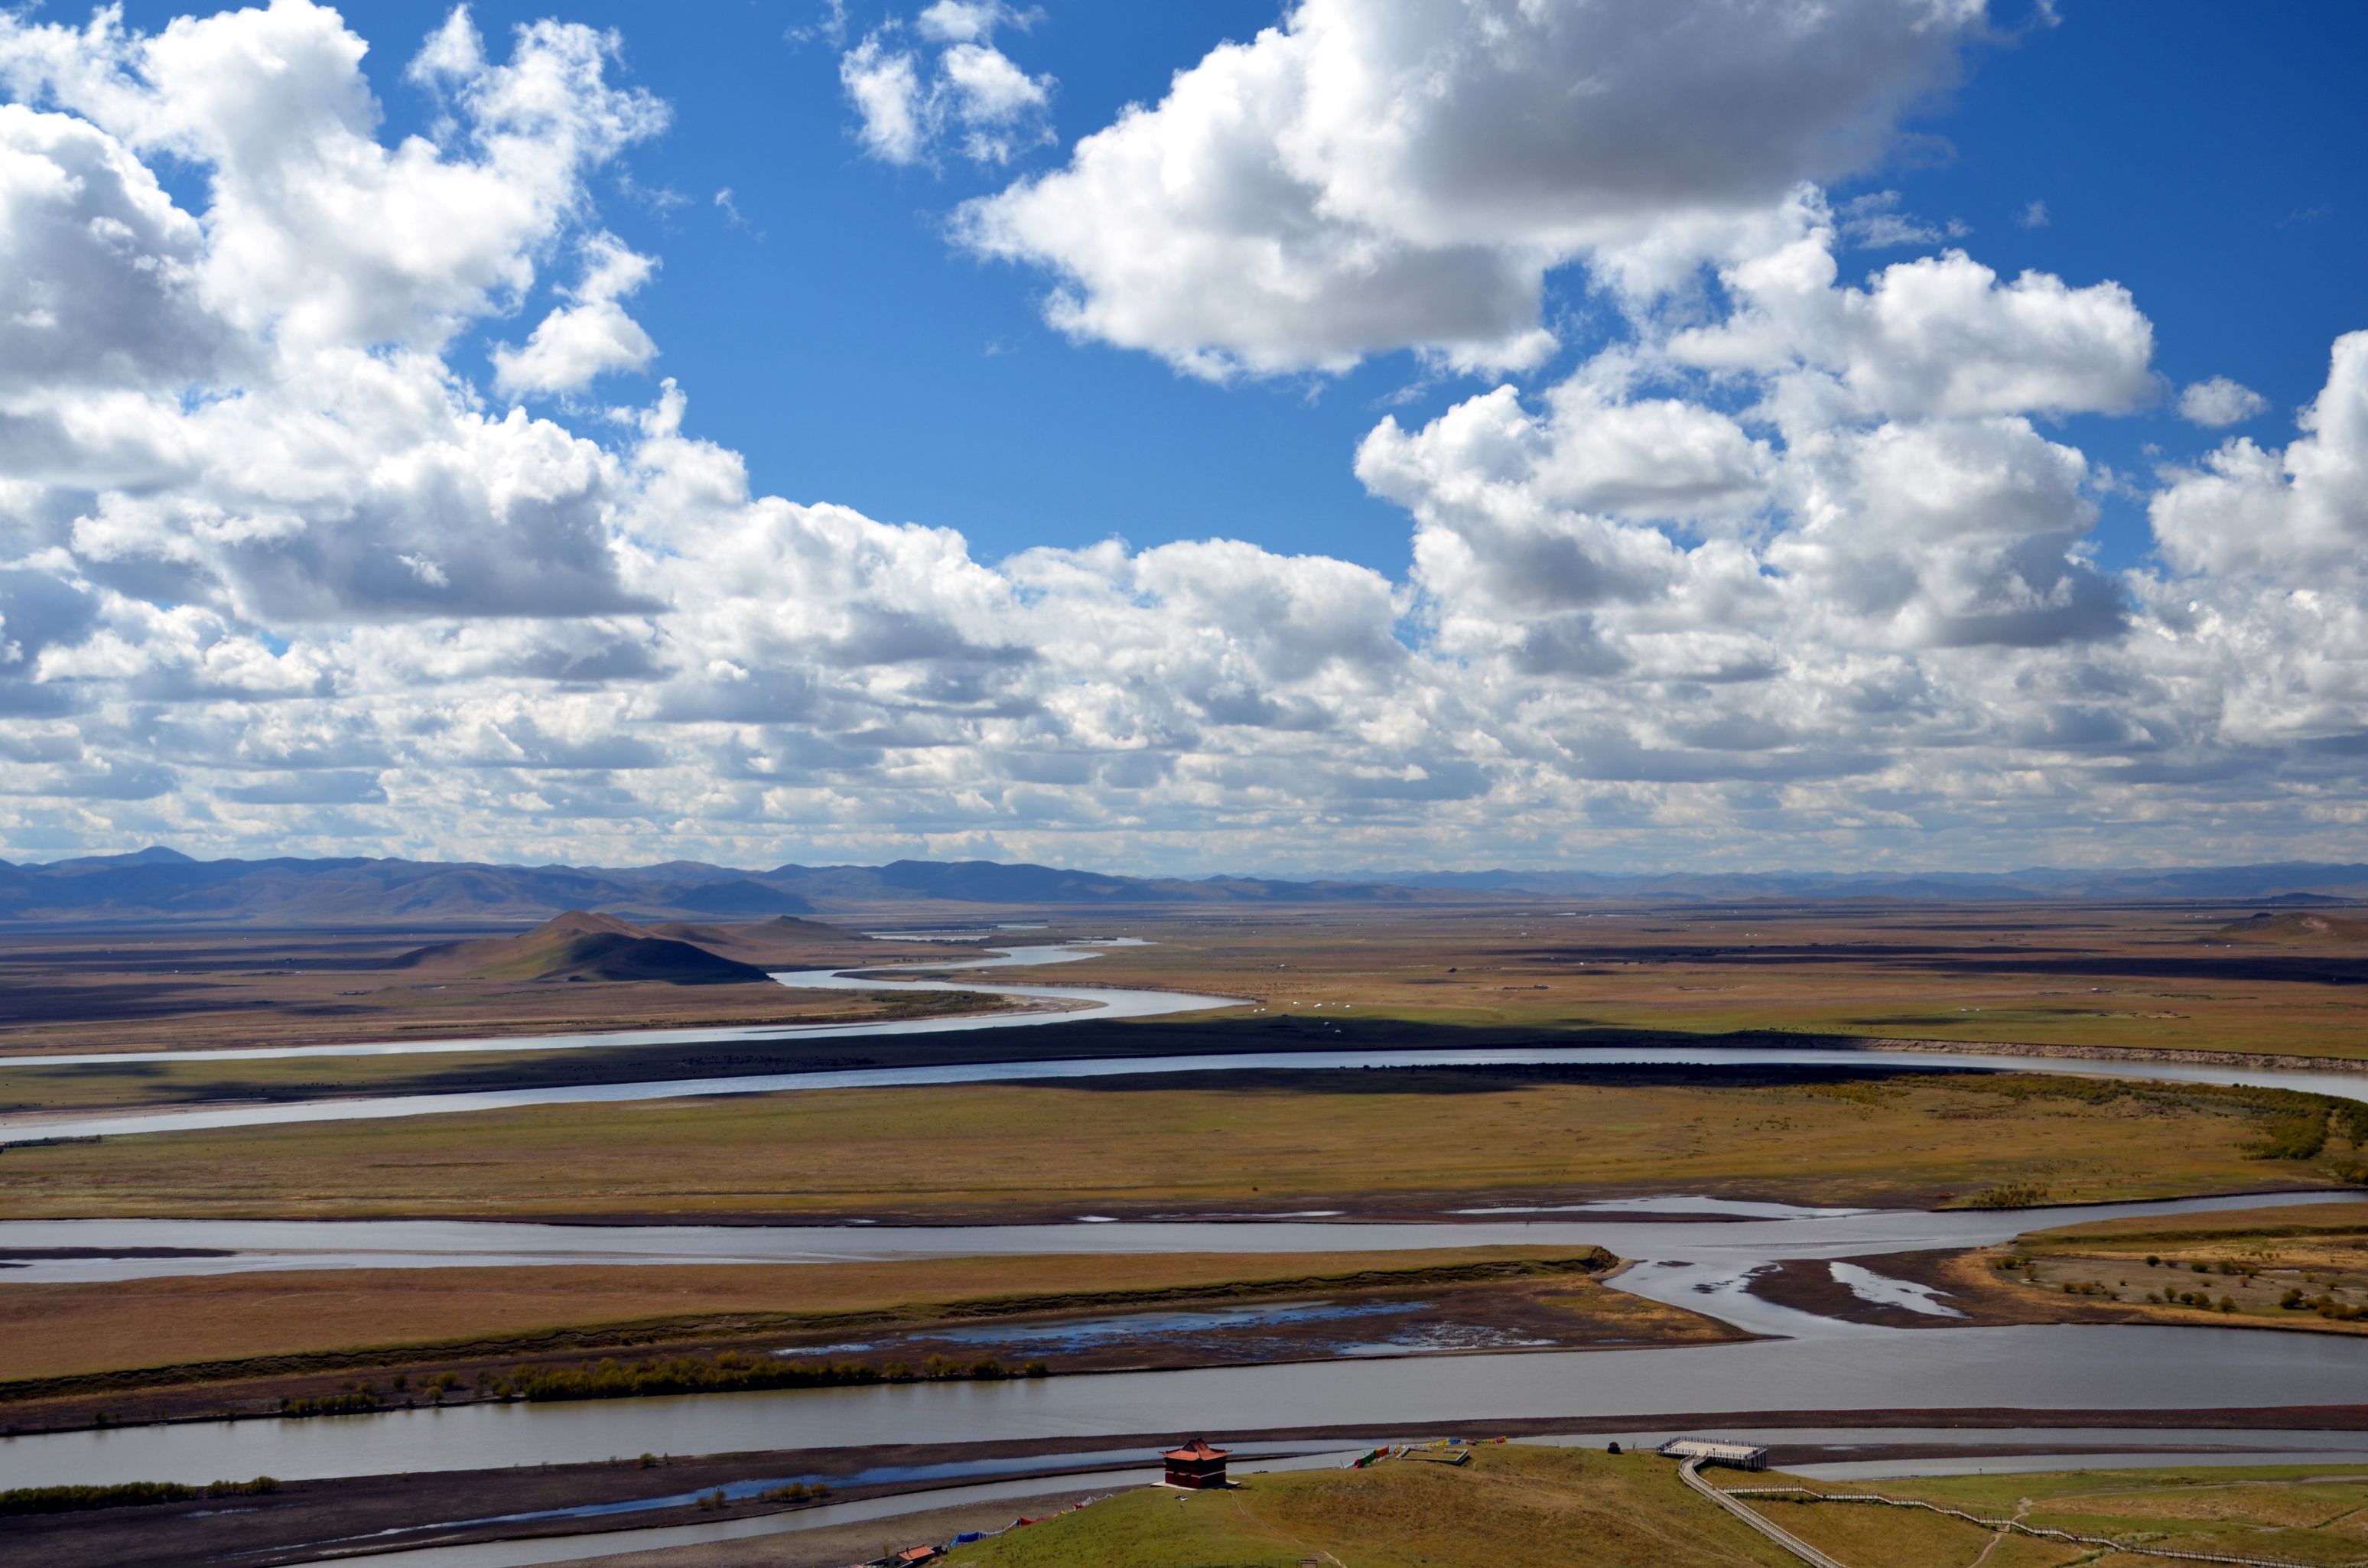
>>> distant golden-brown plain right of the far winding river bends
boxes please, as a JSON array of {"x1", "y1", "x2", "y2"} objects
[{"x1": 1011, "y1": 905, "x2": 2368, "y2": 1059}]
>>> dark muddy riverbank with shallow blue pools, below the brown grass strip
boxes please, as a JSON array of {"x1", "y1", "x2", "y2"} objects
[{"x1": 0, "y1": 1246, "x2": 1757, "y2": 1436}]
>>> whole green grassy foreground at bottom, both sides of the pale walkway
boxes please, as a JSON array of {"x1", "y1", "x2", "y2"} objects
[{"x1": 949, "y1": 1443, "x2": 2368, "y2": 1568}]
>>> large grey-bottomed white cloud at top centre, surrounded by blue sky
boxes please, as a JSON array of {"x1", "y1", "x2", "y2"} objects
[{"x1": 961, "y1": 0, "x2": 1984, "y2": 376}]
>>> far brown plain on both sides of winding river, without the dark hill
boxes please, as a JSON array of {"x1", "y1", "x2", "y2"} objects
[{"x1": 0, "y1": 900, "x2": 2368, "y2": 1059}]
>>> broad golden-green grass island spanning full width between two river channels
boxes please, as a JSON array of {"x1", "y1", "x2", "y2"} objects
[{"x1": 0, "y1": 1071, "x2": 2359, "y2": 1220}]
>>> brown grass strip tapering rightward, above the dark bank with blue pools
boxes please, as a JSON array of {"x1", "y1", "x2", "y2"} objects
[{"x1": 0, "y1": 1246, "x2": 1686, "y2": 1386}]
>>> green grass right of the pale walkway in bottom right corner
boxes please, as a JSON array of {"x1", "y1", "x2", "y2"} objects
[{"x1": 1707, "y1": 1466, "x2": 2368, "y2": 1568}]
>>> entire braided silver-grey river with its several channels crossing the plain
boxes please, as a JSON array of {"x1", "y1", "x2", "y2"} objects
[{"x1": 0, "y1": 950, "x2": 2368, "y2": 1488}]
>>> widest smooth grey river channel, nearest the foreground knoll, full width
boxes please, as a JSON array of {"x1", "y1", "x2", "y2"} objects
[{"x1": 0, "y1": 1324, "x2": 2368, "y2": 1485}]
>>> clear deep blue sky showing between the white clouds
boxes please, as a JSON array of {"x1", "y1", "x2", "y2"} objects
[{"x1": 87, "y1": 0, "x2": 2368, "y2": 573}]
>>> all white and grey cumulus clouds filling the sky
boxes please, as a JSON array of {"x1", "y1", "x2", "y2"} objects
[{"x1": 0, "y1": 0, "x2": 2368, "y2": 869}]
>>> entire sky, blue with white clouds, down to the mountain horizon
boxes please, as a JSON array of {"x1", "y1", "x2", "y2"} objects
[{"x1": 0, "y1": 0, "x2": 2368, "y2": 872}]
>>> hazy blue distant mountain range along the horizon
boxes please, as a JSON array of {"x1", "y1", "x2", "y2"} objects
[{"x1": 0, "y1": 848, "x2": 2368, "y2": 926}]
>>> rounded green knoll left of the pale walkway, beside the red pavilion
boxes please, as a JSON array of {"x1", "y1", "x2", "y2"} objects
[{"x1": 949, "y1": 1445, "x2": 1797, "y2": 1568}]
